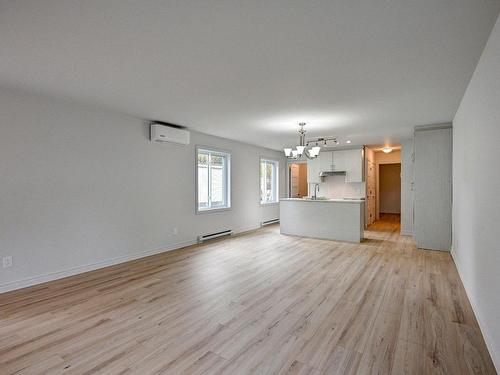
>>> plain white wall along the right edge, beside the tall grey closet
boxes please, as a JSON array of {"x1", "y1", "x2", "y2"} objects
[{"x1": 452, "y1": 14, "x2": 500, "y2": 372}]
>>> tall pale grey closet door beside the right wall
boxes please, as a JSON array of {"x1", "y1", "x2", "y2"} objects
[{"x1": 414, "y1": 127, "x2": 452, "y2": 250}]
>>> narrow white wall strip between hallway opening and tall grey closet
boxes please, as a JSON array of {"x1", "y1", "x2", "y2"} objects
[{"x1": 401, "y1": 139, "x2": 413, "y2": 235}]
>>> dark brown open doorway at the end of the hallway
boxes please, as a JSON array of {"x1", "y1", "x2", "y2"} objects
[{"x1": 379, "y1": 163, "x2": 401, "y2": 215}]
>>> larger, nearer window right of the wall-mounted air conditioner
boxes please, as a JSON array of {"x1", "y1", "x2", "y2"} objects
[{"x1": 196, "y1": 148, "x2": 231, "y2": 212}]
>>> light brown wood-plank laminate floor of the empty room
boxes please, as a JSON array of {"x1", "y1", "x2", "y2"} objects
[{"x1": 0, "y1": 216, "x2": 495, "y2": 375}]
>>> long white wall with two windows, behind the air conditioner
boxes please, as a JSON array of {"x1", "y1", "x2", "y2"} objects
[{"x1": 0, "y1": 90, "x2": 286, "y2": 291}]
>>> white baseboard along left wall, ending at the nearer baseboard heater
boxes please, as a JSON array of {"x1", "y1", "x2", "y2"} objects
[{"x1": 0, "y1": 240, "x2": 196, "y2": 293}]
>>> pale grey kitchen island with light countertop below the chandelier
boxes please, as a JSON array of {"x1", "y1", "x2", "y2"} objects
[{"x1": 280, "y1": 198, "x2": 365, "y2": 243}]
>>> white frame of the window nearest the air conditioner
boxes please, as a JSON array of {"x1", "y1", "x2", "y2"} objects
[{"x1": 194, "y1": 146, "x2": 231, "y2": 214}]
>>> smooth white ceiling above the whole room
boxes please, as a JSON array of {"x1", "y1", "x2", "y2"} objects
[{"x1": 0, "y1": 0, "x2": 500, "y2": 148}]
